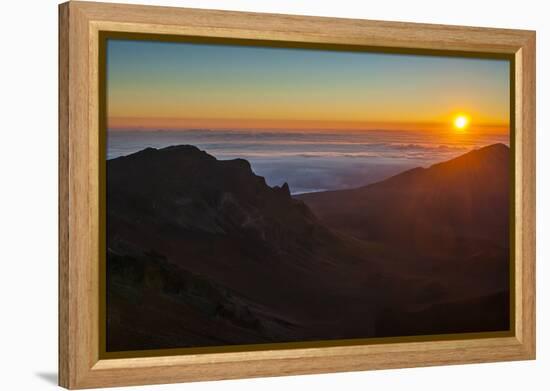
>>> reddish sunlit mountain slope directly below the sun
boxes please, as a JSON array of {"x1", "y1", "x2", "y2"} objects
[{"x1": 297, "y1": 144, "x2": 510, "y2": 253}]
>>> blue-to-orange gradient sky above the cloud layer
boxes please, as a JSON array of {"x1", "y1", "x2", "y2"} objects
[{"x1": 107, "y1": 39, "x2": 510, "y2": 133}]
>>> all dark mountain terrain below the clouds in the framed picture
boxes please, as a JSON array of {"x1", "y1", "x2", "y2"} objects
[{"x1": 107, "y1": 144, "x2": 509, "y2": 351}]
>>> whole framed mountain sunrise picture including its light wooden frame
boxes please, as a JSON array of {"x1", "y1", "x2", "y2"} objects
[{"x1": 59, "y1": 2, "x2": 535, "y2": 388}]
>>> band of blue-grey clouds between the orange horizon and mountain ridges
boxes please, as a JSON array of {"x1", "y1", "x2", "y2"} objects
[{"x1": 107, "y1": 129, "x2": 509, "y2": 194}]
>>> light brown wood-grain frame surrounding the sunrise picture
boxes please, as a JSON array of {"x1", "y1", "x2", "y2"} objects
[{"x1": 59, "y1": 2, "x2": 535, "y2": 389}]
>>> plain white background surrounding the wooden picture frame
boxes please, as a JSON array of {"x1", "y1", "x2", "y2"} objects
[{"x1": 0, "y1": 0, "x2": 550, "y2": 391}]
